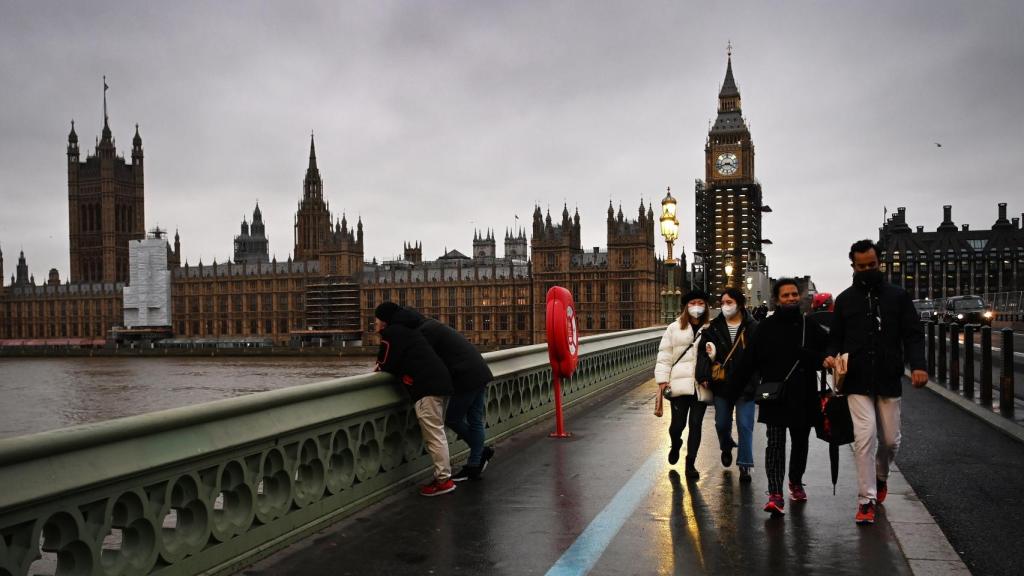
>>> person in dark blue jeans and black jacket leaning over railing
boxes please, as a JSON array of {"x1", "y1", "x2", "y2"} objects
[{"x1": 391, "y1": 307, "x2": 495, "y2": 482}]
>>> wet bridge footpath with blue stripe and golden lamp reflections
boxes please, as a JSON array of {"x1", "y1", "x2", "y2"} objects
[{"x1": 241, "y1": 381, "x2": 921, "y2": 576}]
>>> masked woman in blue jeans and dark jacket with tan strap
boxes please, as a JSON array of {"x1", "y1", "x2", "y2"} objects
[{"x1": 706, "y1": 288, "x2": 758, "y2": 483}]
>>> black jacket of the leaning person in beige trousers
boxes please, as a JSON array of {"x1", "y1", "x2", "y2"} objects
[{"x1": 377, "y1": 323, "x2": 453, "y2": 402}]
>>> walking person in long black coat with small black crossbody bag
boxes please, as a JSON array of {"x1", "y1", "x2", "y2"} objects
[{"x1": 739, "y1": 278, "x2": 827, "y2": 516}]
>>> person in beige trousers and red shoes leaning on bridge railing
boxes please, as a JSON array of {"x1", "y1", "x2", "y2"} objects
[{"x1": 374, "y1": 302, "x2": 455, "y2": 496}]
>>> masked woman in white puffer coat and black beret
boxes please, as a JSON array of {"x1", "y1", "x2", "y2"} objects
[{"x1": 654, "y1": 290, "x2": 712, "y2": 480}]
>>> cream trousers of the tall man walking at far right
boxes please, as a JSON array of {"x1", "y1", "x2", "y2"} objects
[{"x1": 847, "y1": 394, "x2": 901, "y2": 504}]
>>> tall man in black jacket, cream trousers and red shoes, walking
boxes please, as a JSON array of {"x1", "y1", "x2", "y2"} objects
[{"x1": 824, "y1": 240, "x2": 928, "y2": 524}]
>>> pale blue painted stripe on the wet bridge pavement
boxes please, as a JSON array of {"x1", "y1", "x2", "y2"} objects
[{"x1": 547, "y1": 451, "x2": 665, "y2": 576}]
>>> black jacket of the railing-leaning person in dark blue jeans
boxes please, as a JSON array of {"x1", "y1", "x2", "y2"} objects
[{"x1": 391, "y1": 307, "x2": 494, "y2": 393}]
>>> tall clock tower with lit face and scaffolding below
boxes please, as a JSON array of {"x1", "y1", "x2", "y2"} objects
[{"x1": 694, "y1": 45, "x2": 767, "y2": 293}]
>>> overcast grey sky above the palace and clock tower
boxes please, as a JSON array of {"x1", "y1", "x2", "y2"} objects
[{"x1": 0, "y1": 0, "x2": 1024, "y2": 292}]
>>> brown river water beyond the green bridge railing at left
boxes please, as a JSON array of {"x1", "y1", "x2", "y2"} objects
[{"x1": 0, "y1": 357, "x2": 375, "y2": 438}]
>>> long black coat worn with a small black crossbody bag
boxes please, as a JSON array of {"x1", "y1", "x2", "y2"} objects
[{"x1": 738, "y1": 314, "x2": 828, "y2": 427}]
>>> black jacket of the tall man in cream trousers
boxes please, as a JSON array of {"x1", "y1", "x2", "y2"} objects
[{"x1": 828, "y1": 283, "x2": 926, "y2": 397}]
